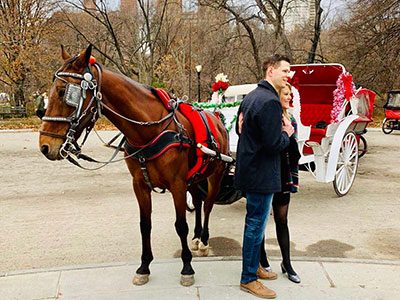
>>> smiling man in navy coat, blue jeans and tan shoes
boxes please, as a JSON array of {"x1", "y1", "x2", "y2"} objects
[{"x1": 235, "y1": 54, "x2": 294, "y2": 298}]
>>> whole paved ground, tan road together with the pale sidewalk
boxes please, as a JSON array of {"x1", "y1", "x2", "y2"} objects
[{"x1": 0, "y1": 130, "x2": 400, "y2": 300}]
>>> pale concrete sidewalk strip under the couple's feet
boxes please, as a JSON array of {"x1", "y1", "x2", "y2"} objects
[{"x1": 0, "y1": 257, "x2": 400, "y2": 300}]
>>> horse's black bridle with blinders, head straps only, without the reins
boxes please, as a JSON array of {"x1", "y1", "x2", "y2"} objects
[{"x1": 40, "y1": 59, "x2": 102, "y2": 158}]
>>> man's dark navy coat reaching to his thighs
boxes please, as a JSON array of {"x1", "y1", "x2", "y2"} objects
[{"x1": 235, "y1": 80, "x2": 289, "y2": 194}]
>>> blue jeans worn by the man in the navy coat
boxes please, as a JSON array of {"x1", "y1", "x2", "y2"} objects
[{"x1": 240, "y1": 193, "x2": 274, "y2": 283}]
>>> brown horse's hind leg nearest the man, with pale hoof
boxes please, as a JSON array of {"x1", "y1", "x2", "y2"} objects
[{"x1": 198, "y1": 167, "x2": 224, "y2": 256}]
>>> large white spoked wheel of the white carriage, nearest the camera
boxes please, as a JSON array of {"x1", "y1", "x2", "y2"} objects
[{"x1": 333, "y1": 131, "x2": 358, "y2": 197}]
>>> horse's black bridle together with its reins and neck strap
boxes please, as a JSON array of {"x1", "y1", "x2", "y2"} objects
[{"x1": 40, "y1": 56, "x2": 184, "y2": 170}]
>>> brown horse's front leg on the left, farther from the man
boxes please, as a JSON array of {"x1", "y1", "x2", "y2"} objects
[{"x1": 133, "y1": 180, "x2": 153, "y2": 285}]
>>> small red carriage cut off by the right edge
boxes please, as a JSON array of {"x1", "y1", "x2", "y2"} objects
[{"x1": 382, "y1": 90, "x2": 400, "y2": 134}]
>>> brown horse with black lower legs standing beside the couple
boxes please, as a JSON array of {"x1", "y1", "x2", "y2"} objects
[{"x1": 39, "y1": 46, "x2": 229, "y2": 286}]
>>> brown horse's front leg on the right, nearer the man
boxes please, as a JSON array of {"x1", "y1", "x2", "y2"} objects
[{"x1": 170, "y1": 182, "x2": 194, "y2": 286}]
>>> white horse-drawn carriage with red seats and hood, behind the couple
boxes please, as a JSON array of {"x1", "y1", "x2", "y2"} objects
[{"x1": 205, "y1": 64, "x2": 375, "y2": 196}]
